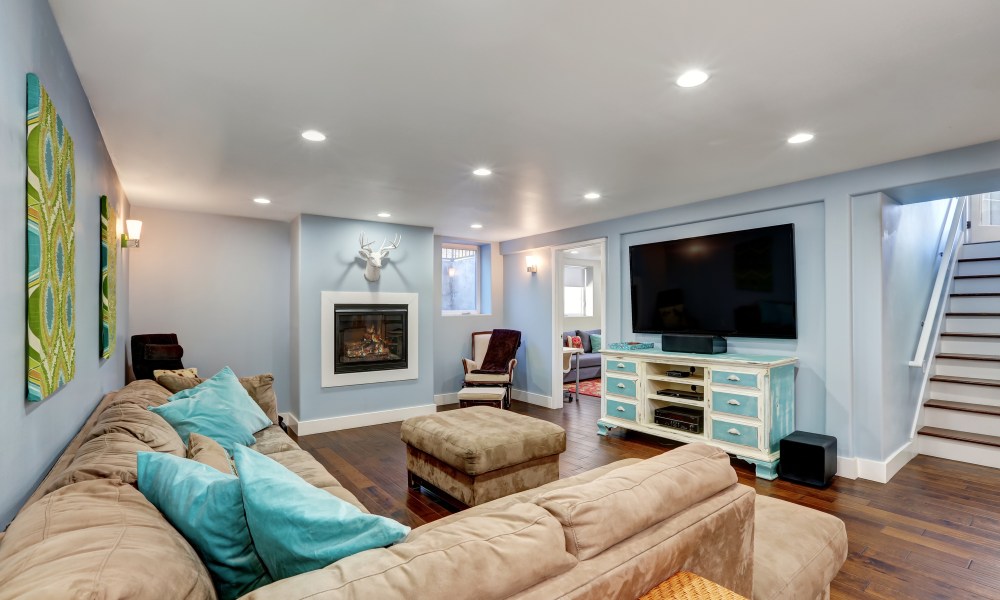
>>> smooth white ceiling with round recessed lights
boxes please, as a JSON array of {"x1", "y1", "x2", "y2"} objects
[{"x1": 50, "y1": 0, "x2": 1000, "y2": 240}]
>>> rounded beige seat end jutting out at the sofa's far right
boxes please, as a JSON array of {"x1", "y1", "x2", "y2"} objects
[{"x1": 753, "y1": 496, "x2": 847, "y2": 600}]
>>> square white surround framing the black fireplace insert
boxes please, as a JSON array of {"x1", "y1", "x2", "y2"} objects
[{"x1": 320, "y1": 292, "x2": 419, "y2": 387}]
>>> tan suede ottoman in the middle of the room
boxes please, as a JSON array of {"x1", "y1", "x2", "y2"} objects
[{"x1": 400, "y1": 406, "x2": 566, "y2": 506}]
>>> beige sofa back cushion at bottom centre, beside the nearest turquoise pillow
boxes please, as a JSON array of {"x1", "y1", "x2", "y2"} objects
[{"x1": 237, "y1": 504, "x2": 577, "y2": 600}]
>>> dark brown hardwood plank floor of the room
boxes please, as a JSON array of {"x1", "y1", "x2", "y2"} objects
[{"x1": 299, "y1": 396, "x2": 1000, "y2": 600}]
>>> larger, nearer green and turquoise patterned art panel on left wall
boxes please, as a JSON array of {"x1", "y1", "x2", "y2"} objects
[{"x1": 27, "y1": 73, "x2": 76, "y2": 402}]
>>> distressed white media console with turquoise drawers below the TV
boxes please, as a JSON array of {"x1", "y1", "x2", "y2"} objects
[{"x1": 597, "y1": 348, "x2": 796, "y2": 479}]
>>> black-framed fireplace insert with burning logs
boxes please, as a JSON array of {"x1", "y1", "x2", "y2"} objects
[{"x1": 334, "y1": 304, "x2": 408, "y2": 373}]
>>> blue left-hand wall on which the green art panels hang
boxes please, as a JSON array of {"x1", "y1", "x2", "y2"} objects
[{"x1": 0, "y1": 0, "x2": 129, "y2": 528}]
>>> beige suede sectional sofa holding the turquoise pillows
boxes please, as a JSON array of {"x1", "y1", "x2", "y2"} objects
[{"x1": 0, "y1": 381, "x2": 847, "y2": 600}]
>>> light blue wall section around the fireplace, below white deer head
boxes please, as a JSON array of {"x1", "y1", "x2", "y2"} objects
[{"x1": 292, "y1": 215, "x2": 432, "y2": 421}]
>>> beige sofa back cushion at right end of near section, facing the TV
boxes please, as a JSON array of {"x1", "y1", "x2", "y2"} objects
[{"x1": 535, "y1": 443, "x2": 736, "y2": 560}]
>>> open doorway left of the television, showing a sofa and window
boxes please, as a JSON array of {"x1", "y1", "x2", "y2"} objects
[{"x1": 552, "y1": 239, "x2": 607, "y2": 405}]
